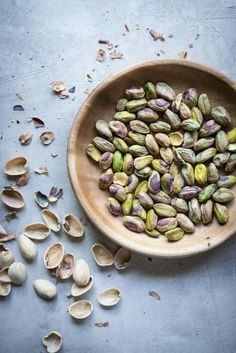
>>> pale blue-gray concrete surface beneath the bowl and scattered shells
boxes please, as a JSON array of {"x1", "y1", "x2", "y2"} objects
[{"x1": 0, "y1": 0, "x2": 236, "y2": 353}]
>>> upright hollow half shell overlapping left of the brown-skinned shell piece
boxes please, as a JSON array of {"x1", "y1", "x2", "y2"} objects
[{"x1": 44, "y1": 243, "x2": 64, "y2": 270}]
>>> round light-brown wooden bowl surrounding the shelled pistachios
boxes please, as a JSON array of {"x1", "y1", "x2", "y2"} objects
[{"x1": 68, "y1": 60, "x2": 236, "y2": 257}]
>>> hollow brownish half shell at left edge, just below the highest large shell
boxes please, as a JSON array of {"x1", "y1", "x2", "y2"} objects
[{"x1": 0, "y1": 186, "x2": 25, "y2": 209}]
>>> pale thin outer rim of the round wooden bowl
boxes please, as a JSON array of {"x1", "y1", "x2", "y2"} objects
[{"x1": 67, "y1": 59, "x2": 236, "y2": 258}]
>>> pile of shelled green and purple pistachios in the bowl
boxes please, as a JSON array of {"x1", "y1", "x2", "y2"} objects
[{"x1": 86, "y1": 82, "x2": 236, "y2": 241}]
